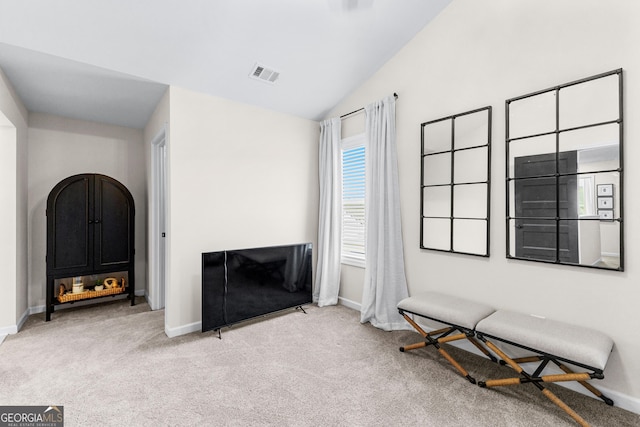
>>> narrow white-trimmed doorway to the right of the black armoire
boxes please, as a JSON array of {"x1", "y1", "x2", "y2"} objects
[{"x1": 149, "y1": 127, "x2": 167, "y2": 310}]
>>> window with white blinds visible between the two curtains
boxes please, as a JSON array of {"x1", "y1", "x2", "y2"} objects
[{"x1": 342, "y1": 134, "x2": 365, "y2": 267}]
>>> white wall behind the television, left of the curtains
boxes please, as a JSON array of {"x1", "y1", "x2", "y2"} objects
[{"x1": 165, "y1": 87, "x2": 319, "y2": 336}]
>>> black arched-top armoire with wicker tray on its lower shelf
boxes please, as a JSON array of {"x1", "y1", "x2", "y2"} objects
[{"x1": 46, "y1": 173, "x2": 135, "y2": 321}]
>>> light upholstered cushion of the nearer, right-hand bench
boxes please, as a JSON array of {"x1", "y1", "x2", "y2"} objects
[{"x1": 476, "y1": 310, "x2": 613, "y2": 370}]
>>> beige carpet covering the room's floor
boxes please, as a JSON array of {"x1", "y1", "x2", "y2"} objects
[{"x1": 0, "y1": 301, "x2": 640, "y2": 427}]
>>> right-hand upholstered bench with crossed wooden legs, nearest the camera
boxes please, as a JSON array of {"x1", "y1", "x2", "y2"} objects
[{"x1": 476, "y1": 310, "x2": 613, "y2": 425}]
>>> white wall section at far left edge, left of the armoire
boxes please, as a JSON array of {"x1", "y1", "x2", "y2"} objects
[{"x1": 0, "y1": 69, "x2": 28, "y2": 335}]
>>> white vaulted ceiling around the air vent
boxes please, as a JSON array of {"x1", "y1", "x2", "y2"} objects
[{"x1": 0, "y1": 0, "x2": 451, "y2": 128}]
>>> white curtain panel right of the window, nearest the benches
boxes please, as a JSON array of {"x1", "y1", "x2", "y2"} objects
[{"x1": 360, "y1": 96, "x2": 410, "y2": 331}]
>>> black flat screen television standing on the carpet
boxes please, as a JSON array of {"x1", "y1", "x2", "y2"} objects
[{"x1": 202, "y1": 243, "x2": 312, "y2": 332}]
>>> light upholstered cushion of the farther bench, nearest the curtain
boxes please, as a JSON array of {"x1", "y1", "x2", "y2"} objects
[{"x1": 398, "y1": 291, "x2": 495, "y2": 330}]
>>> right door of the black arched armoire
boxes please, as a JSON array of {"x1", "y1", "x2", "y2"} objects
[{"x1": 94, "y1": 175, "x2": 134, "y2": 270}]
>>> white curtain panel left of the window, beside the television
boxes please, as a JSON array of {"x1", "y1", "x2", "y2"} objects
[{"x1": 313, "y1": 118, "x2": 342, "y2": 307}]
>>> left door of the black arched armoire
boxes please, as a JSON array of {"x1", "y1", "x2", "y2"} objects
[{"x1": 47, "y1": 175, "x2": 93, "y2": 271}]
